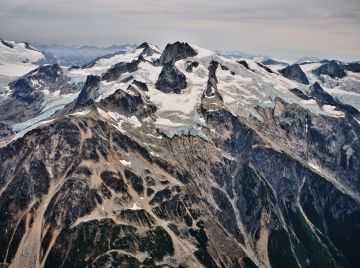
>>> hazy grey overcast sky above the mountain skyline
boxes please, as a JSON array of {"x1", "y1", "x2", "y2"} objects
[{"x1": 0, "y1": 0, "x2": 360, "y2": 60}]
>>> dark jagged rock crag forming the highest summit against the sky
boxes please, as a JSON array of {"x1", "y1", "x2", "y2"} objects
[{"x1": 159, "y1": 42, "x2": 197, "y2": 65}]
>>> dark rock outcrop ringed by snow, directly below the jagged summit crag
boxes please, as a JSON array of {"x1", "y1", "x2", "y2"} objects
[{"x1": 155, "y1": 64, "x2": 187, "y2": 94}]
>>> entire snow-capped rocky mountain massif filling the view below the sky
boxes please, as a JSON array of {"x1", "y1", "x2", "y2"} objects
[{"x1": 0, "y1": 41, "x2": 360, "y2": 268}]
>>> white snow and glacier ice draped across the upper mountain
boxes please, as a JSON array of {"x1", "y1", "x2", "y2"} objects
[{"x1": 1, "y1": 40, "x2": 360, "y2": 138}]
